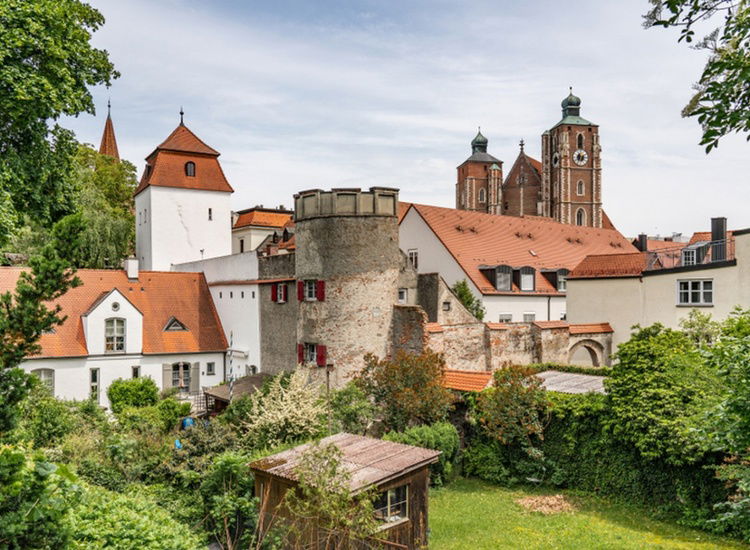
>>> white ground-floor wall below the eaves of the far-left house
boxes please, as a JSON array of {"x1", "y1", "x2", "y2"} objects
[{"x1": 21, "y1": 353, "x2": 224, "y2": 407}]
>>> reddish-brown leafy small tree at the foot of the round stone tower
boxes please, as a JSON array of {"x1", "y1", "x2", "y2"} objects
[{"x1": 355, "y1": 350, "x2": 453, "y2": 431}]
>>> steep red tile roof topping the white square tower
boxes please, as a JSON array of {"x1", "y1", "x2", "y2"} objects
[{"x1": 135, "y1": 124, "x2": 234, "y2": 195}]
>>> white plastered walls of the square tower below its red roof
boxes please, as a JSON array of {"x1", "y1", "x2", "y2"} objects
[{"x1": 135, "y1": 186, "x2": 232, "y2": 271}]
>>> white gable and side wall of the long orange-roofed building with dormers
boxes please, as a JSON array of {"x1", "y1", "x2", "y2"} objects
[{"x1": 399, "y1": 208, "x2": 566, "y2": 322}]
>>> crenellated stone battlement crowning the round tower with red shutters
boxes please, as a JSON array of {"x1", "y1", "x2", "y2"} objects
[{"x1": 294, "y1": 187, "x2": 398, "y2": 222}]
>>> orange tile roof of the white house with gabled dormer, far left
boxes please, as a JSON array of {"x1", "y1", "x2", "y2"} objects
[{"x1": 0, "y1": 267, "x2": 227, "y2": 357}]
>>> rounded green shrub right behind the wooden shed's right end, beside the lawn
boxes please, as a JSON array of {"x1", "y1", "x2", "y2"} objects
[{"x1": 383, "y1": 422, "x2": 461, "y2": 486}]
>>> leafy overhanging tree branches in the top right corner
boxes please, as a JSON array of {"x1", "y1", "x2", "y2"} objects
[{"x1": 644, "y1": 0, "x2": 750, "y2": 153}]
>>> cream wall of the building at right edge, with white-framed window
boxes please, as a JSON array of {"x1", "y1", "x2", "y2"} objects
[{"x1": 568, "y1": 234, "x2": 750, "y2": 345}]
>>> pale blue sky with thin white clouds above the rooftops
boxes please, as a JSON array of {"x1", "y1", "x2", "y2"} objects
[{"x1": 63, "y1": 0, "x2": 750, "y2": 236}]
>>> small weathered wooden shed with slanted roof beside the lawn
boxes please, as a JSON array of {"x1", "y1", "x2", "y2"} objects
[{"x1": 250, "y1": 433, "x2": 440, "y2": 550}]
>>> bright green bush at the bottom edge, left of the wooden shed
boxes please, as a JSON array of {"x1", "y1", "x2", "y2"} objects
[{"x1": 71, "y1": 487, "x2": 205, "y2": 550}]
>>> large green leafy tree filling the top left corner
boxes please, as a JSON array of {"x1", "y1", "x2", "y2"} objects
[{"x1": 0, "y1": 0, "x2": 119, "y2": 244}]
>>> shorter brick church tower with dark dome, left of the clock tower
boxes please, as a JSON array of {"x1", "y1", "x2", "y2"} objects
[{"x1": 456, "y1": 129, "x2": 503, "y2": 214}]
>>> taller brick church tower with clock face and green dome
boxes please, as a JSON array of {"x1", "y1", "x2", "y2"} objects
[{"x1": 541, "y1": 88, "x2": 602, "y2": 227}]
